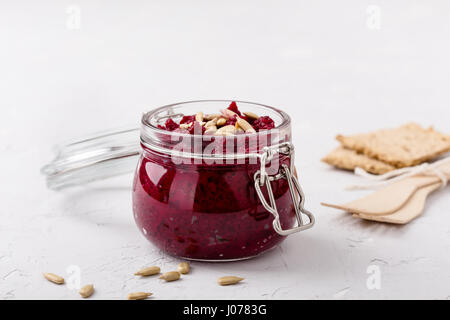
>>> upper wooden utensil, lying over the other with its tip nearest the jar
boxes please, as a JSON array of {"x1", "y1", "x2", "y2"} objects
[{"x1": 322, "y1": 176, "x2": 441, "y2": 216}]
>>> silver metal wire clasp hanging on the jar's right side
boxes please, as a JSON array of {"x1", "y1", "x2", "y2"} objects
[{"x1": 254, "y1": 142, "x2": 315, "y2": 236}]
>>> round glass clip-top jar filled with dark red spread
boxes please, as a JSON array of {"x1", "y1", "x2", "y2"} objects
[{"x1": 133, "y1": 101, "x2": 314, "y2": 261}]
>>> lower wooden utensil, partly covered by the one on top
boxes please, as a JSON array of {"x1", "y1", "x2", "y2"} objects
[{"x1": 353, "y1": 182, "x2": 442, "y2": 224}]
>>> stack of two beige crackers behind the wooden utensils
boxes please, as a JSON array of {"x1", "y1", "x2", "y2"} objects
[{"x1": 322, "y1": 123, "x2": 450, "y2": 174}]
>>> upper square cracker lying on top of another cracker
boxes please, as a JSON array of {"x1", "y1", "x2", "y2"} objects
[{"x1": 336, "y1": 123, "x2": 450, "y2": 168}]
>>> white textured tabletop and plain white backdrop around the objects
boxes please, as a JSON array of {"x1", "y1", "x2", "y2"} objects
[{"x1": 0, "y1": 0, "x2": 450, "y2": 299}]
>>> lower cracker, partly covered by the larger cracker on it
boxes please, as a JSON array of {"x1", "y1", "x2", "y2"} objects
[{"x1": 322, "y1": 147, "x2": 395, "y2": 174}]
